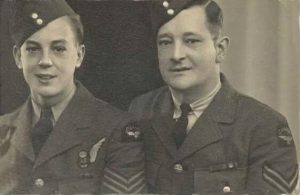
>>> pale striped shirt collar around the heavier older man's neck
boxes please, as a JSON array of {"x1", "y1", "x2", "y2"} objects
[{"x1": 170, "y1": 81, "x2": 221, "y2": 119}]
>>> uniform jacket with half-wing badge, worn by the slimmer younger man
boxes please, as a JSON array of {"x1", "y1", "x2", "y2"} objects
[{"x1": 0, "y1": 84, "x2": 144, "y2": 194}]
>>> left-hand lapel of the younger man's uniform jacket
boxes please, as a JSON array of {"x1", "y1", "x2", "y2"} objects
[{"x1": 10, "y1": 98, "x2": 34, "y2": 161}]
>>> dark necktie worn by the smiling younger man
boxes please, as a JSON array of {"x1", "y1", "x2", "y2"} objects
[{"x1": 31, "y1": 108, "x2": 53, "y2": 156}]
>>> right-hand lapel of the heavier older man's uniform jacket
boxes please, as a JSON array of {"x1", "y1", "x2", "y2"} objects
[{"x1": 175, "y1": 75, "x2": 237, "y2": 161}]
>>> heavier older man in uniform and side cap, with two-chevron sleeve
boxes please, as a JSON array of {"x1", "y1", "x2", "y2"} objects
[{"x1": 130, "y1": 0, "x2": 298, "y2": 194}]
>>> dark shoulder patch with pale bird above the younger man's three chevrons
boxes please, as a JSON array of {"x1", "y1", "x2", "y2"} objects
[{"x1": 122, "y1": 123, "x2": 142, "y2": 142}]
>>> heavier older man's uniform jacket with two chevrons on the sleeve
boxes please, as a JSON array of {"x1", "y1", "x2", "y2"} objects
[{"x1": 130, "y1": 76, "x2": 297, "y2": 194}]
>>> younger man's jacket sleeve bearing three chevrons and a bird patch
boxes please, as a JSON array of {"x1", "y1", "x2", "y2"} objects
[{"x1": 102, "y1": 120, "x2": 146, "y2": 194}]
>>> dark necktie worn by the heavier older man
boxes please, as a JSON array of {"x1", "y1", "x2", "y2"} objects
[{"x1": 173, "y1": 103, "x2": 192, "y2": 148}]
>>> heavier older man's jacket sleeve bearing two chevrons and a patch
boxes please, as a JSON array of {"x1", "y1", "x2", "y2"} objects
[{"x1": 247, "y1": 116, "x2": 298, "y2": 194}]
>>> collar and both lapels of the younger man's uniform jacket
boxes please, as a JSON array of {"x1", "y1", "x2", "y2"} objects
[{"x1": 8, "y1": 82, "x2": 104, "y2": 167}]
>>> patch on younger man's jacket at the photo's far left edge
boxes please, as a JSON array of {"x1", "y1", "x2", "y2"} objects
[{"x1": 0, "y1": 126, "x2": 16, "y2": 156}]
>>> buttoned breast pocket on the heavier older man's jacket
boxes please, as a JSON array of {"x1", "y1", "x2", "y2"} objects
[{"x1": 194, "y1": 168, "x2": 247, "y2": 193}]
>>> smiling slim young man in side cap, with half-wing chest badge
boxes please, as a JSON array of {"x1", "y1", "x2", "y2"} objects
[{"x1": 0, "y1": 0, "x2": 145, "y2": 194}]
